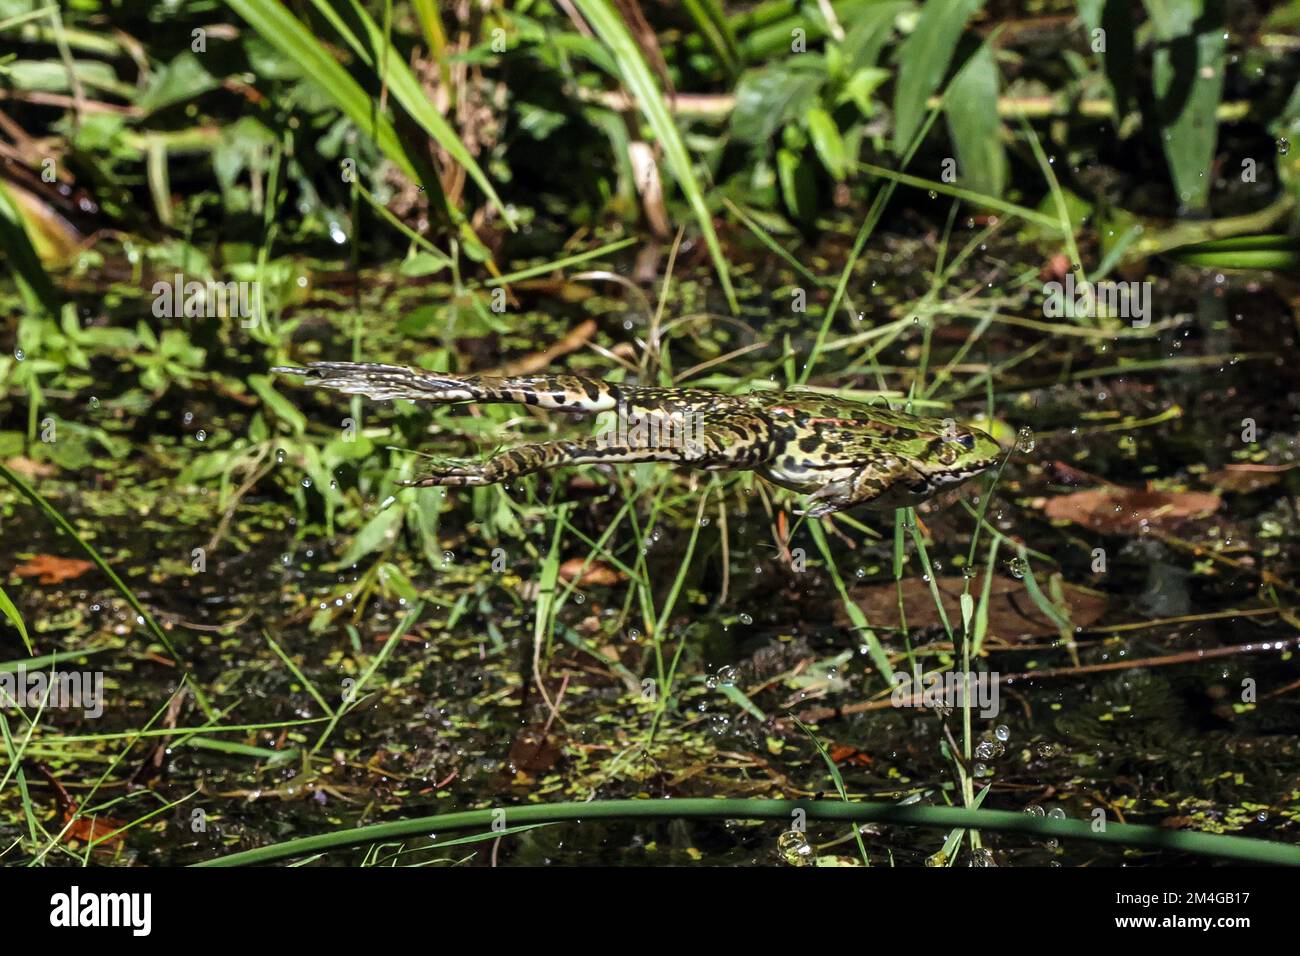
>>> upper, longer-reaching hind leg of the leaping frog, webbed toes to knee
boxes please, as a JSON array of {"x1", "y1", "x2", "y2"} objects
[{"x1": 272, "y1": 362, "x2": 621, "y2": 412}]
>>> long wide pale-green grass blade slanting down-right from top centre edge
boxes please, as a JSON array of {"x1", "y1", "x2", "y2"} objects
[{"x1": 575, "y1": 0, "x2": 740, "y2": 313}]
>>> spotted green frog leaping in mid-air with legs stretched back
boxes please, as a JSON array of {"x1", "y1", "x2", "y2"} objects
[{"x1": 272, "y1": 362, "x2": 1002, "y2": 518}]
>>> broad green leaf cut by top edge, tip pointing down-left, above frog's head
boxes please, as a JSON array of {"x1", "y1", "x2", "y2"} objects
[{"x1": 893, "y1": 0, "x2": 984, "y2": 156}]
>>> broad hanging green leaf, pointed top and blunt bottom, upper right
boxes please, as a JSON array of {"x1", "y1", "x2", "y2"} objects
[{"x1": 944, "y1": 43, "x2": 1006, "y2": 196}]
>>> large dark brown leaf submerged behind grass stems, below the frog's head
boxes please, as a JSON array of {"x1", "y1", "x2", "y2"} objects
[{"x1": 836, "y1": 575, "x2": 1106, "y2": 640}]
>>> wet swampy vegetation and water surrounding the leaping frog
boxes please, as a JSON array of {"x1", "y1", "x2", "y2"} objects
[{"x1": 0, "y1": 0, "x2": 1300, "y2": 866}]
